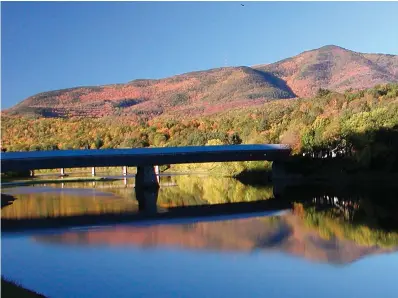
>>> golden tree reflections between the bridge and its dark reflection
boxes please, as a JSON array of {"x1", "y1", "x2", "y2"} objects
[{"x1": 2, "y1": 176, "x2": 272, "y2": 219}]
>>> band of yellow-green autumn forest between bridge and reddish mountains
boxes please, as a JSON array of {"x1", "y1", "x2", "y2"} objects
[{"x1": 2, "y1": 84, "x2": 398, "y2": 172}]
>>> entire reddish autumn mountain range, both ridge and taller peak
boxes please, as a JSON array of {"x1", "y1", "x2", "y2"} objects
[{"x1": 6, "y1": 46, "x2": 398, "y2": 118}]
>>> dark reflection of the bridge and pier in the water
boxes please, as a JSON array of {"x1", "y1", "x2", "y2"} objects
[{"x1": 1, "y1": 188, "x2": 291, "y2": 232}]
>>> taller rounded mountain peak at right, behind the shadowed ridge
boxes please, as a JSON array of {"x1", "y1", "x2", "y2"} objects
[{"x1": 254, "y1": 45, "x2": 398, "y2": 97}]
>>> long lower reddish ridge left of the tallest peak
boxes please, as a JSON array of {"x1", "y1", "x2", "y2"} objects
[{"x1": 9, "y1": 67, "x2": 295, "y2": 117}]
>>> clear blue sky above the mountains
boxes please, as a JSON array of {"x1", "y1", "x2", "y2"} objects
[{"x1": 1, "y1": 2, "x2": 398, "y2": 109}]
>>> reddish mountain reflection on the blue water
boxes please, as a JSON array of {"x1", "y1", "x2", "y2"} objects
[{"x1": 35, "y1": 214, "x2": 398, "y2": 263}]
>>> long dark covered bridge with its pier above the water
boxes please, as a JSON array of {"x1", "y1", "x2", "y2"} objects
[{"x1": 1, "y1": 144, "x2": 291, "y2": 188}]
